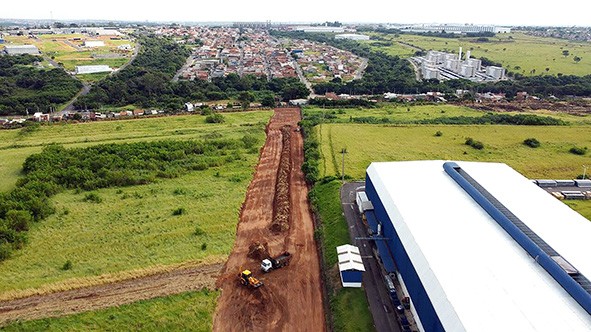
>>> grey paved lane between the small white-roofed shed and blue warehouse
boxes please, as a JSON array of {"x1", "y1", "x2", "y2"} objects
[{"x1": 341, "y1": 182, "x2": 401, "y2": 332}]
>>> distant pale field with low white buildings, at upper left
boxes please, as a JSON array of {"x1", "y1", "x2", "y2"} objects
[{"x1": 6, "y1": 34, "x2": 135, "y2": 71}]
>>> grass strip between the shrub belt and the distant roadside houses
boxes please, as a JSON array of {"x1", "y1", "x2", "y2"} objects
[{"x1": 0, "y1": 111, "x2": 271, "y2": 191}]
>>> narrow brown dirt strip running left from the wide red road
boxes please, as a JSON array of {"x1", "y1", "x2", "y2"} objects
[{"x1": 0, "y1": 264, "x2": 222, "y2": 326}]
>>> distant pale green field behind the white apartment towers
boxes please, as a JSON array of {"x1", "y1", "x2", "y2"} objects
[{"x1": 382, "y1": 33, "x2": 591, "y2": 76}]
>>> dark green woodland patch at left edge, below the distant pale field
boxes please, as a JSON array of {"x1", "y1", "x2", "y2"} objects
[{"x1": 0, "y1": 54, "x2": 82, "y2": 115}]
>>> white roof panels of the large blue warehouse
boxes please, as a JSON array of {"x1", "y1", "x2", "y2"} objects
[{"x1": 367, "y1": 161, "x2": 591, "y2": 331}]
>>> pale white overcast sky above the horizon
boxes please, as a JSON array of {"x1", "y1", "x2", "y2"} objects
[{"x1": 0, "y1": 0, "x2": 591, "y2": 26}]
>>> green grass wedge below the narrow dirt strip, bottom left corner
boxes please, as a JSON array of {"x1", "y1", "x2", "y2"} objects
[{"x1": 2, "y1": 290, "x2": 219, "y2": 332}]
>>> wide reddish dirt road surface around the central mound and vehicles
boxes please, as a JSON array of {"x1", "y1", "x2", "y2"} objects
[{"x1": 214, "y1": 109, "x2": 326, "y2": 331}]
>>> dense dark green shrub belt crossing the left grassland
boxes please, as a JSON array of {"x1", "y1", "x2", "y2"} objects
[{"x1": 0, "y1": 135, "x2": 256, "y2": 261}]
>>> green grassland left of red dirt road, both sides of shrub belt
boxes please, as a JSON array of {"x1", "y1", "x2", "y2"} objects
[{"x1": 0, "y1": 112, "x2": 271, "y2": 295}]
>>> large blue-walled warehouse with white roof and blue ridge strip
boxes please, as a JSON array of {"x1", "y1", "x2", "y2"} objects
[{"x1": 365, "y1": 161, "x2": 591, "y2": 331}]
